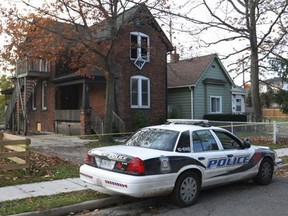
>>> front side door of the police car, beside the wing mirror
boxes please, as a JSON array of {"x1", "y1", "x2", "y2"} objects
[{"x1": 213, "y1": 130, "x2": 257, "y2": 181}]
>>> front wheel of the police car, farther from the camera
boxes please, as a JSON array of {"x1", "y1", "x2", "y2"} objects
[{"x1": 254, "y1": 158, "x2": 274, "y2": 185}]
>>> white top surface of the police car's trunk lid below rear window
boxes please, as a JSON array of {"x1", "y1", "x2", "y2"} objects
[{"x1": 89, "y1": 145, "x2": 175, "y2": 160}]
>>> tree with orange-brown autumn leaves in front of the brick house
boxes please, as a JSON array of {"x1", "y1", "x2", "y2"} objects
[{"x1": 2, "y1": 0, "x2": 170, "y2": 138}]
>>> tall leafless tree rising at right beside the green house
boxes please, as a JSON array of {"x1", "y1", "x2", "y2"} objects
[{"x1": 166, "y1": 0, "x2": 287, "y2": 121}]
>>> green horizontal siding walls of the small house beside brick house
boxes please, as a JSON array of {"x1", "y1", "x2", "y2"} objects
[{"x1": 168, "y1": 60, "x2": 232, "y2": 119}]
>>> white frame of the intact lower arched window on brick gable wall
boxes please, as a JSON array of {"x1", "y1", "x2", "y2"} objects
[{"x1": 130, "y1": 75, "x2": 150, "y2": 109}]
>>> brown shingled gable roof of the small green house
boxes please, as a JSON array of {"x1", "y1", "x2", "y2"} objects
[{"x1": 167, "y1": 54, "x2": 234, "y2": 88}]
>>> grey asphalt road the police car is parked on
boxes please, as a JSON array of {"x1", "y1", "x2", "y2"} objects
[{"x1": 81, "y1": 177, "x2": 288, "y2": 216}]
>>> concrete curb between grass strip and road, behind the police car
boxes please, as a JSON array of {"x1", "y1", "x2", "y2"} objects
[{"x1": 16, "y1": 196, "x2": 135, "y2": 216}]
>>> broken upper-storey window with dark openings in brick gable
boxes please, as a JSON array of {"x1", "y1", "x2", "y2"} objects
[{"x1": 130, "y1": 32, "x2": 150, "y2": 62}]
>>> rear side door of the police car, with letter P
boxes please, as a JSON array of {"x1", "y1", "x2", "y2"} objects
[{"x1": 192, "y1": 129, "x2": 227, "y2": 187}]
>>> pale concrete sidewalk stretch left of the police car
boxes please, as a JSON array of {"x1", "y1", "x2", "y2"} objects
[{"x1": 0, "y1": 178, "x2": 113, "y2": 202}]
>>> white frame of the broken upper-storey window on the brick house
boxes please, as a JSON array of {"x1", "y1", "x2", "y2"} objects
[{"x1": 130, "y1": 32, "x2": 150, "y2": 62}]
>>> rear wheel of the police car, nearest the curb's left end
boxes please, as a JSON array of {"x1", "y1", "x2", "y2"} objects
[{"x1": 172, "y1": 172, "x2": 200, "y2": 207}]
